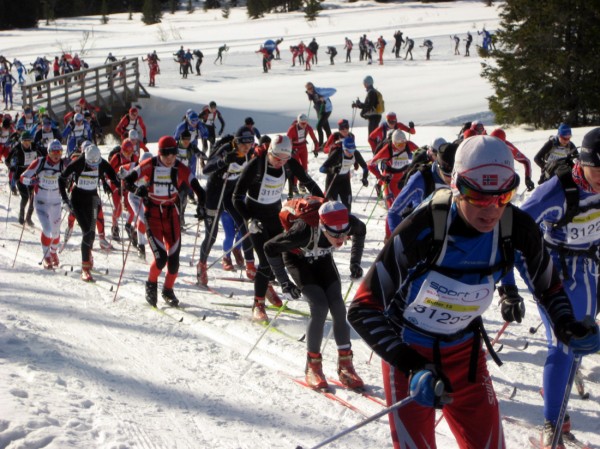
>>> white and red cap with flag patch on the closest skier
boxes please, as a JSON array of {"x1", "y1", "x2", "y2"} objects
[{"x1": 452, "y1": 136, "x2": 519, "y2": 193}]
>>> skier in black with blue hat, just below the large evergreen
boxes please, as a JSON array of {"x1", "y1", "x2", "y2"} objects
[{"x1": 533, "y1": 123, "x2": 579, "y2": 184}]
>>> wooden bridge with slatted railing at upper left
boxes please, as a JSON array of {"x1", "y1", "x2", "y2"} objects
[{"x1": 22, "y1": 58, "x2": 150, "y2": 123}]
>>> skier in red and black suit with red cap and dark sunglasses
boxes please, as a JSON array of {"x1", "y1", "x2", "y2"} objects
[{"x1": 125, "y1": 136, "x2": 206, "y2": 307}]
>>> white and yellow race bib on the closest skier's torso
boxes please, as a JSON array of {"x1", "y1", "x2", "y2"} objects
[{"x1": 404, "y1": 271, "x2": 494, "y2": 335}]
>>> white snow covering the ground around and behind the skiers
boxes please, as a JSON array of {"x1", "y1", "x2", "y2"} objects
[{"x1": 0, "y1": 1, "x2": 600, "y2": 449}]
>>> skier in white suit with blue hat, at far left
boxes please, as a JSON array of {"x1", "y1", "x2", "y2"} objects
[{"x1": 20, "y1": 140, "x2": 65, "y2": 270}]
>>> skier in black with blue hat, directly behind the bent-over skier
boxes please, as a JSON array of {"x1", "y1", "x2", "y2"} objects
[{"x1": 319, "y1": 136, "x2": 369, "y2": 212}]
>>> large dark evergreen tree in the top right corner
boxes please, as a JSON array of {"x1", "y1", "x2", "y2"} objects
[{"x1": 482, "y1": 0, "x2": 600, "y2": 128}]
